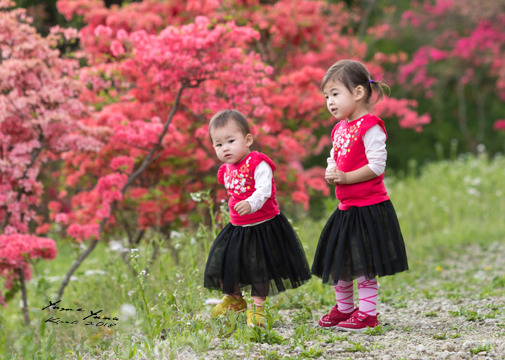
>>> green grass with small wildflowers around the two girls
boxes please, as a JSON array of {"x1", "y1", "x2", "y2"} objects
[{"x1": 0, "y1": 155, "x2": 505, "y2": 359}]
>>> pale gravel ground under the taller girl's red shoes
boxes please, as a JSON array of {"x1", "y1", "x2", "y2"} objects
[{"x1": 177, "y1": 243, "x2": 505, "y2": 360}]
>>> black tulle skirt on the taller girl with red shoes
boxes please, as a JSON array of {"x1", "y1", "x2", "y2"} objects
[{"x1": 312, "y1": 200, "x2": 409, "y2": 285}]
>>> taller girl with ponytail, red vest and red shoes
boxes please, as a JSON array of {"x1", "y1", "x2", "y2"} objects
[{"x1": 312, "y1": 60, "x2": 408, "y2": 332}]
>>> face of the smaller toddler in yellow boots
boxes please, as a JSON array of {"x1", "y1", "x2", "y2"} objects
[{"x1": 210, "y1": 120, "x2": 253, "y2": 164}]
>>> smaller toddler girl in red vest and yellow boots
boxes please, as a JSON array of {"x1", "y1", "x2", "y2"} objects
[{"x1": 204, "y1": 110, "x2": 311, "y2": 326}]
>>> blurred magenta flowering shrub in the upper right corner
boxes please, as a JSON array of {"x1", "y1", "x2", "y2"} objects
[{"x1": 398, "y1": 0, "x2": 505, "y2": 151}]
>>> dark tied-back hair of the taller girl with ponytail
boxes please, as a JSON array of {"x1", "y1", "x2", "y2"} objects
[{"x1": 321, "y1": 60, "x2": 389, "y2": 105}]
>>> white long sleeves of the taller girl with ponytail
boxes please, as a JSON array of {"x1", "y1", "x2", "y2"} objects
[{"x1": 327, "y1": 125, "x2": 387, "y2": 176}]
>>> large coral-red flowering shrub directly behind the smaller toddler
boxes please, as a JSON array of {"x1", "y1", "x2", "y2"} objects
[{"x1": 47, "y1": 0, "x2": 429, "y2": 248}]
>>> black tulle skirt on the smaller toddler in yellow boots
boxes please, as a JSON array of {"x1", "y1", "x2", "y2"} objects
[{"x1": 204, "y1": 213, "x2": 311, "y2": 297}]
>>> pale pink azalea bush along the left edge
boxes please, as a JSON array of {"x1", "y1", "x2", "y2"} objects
[{"x1": 0, "y1": 0, "x2": 93, "y2": 300}]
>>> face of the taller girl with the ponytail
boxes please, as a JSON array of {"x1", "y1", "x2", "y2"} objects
[{"x1": 323, "y1": 80, "x2": 367, "y2": 121}]
